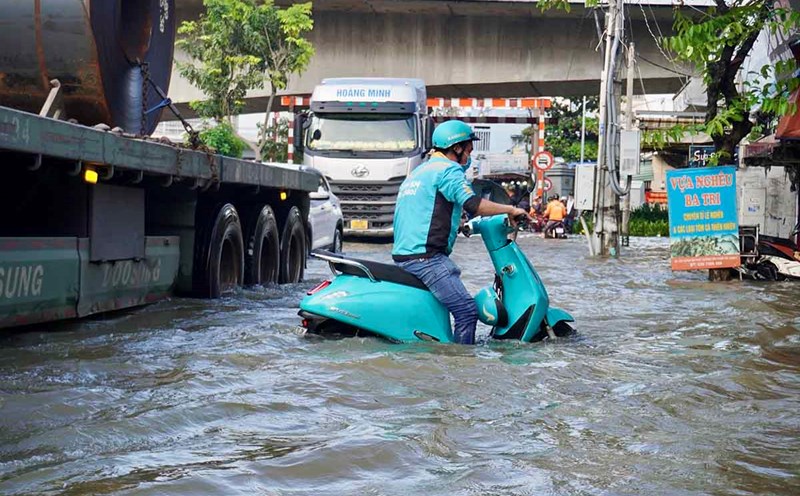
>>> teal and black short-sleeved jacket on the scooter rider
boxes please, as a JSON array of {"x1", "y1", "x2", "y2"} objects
[{"x1": 392, "y1": 153, "x2": 481, "y2": 262}]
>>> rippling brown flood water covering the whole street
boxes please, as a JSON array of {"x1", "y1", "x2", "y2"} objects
[{"x1": 0, "y1": 235, "x2": 800, "y2": 496}]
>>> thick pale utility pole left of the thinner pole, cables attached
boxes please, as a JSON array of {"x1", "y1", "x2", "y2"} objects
[{"x1": 591, "y1": 0, "x2": 624, "y2": 257}]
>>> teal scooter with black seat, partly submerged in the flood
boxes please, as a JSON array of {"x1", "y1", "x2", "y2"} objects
[{"x1": 299, "y1": 215, "x2": 574, "y2": 343}]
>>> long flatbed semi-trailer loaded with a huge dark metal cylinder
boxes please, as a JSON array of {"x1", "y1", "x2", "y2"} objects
[{"x1": 0, "y1": 0, "x2": 317, "y2": 327}]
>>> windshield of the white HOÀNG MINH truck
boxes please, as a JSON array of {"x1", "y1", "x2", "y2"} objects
[{"x1": 306, "y1": 114, "x2": 417, "y2": 152}]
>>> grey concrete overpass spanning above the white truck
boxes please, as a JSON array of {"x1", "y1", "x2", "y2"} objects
[{"x1": 170, "y1": 0, "x2": 711, "y2": 112}]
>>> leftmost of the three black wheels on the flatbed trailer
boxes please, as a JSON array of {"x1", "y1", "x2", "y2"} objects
[{"x1": 201, "y1": 203, "x2": 244, "y2": 298}]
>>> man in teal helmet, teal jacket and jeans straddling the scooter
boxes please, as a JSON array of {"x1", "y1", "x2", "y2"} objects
[{"x1": 392, "y1": 120, "x2": 528, "y2": 344}]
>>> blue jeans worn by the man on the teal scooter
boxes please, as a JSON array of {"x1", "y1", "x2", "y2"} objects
[{"x1": 397, "y1": 253, "x2": 478, "y2": 344}]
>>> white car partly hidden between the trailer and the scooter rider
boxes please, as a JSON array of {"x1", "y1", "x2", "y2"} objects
[{"x1": 303, "y1": 167, "x2": 344, "y2": 253}]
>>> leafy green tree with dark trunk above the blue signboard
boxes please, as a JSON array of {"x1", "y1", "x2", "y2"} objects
[{"x1": 663, "y1": 0, "x2": 800, "y2": 163}]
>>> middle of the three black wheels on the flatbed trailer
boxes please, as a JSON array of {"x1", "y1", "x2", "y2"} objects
[{"x1": 244, "y1": 205, "x2": 281, "y2": 285}]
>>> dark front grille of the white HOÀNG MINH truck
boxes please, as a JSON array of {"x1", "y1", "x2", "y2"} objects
[{"x1": 331, "y1": 177, "x2": 405, "y2": 229}]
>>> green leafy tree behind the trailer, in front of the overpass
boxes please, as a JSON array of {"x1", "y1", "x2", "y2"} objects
[{"x1": 177, "y1": 0, "x2": 314, "y2": 159}]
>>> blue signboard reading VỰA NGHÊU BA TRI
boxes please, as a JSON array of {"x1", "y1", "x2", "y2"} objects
[{"x1": 667, "y1": 166, "x2": 740, "y2": 270}]
